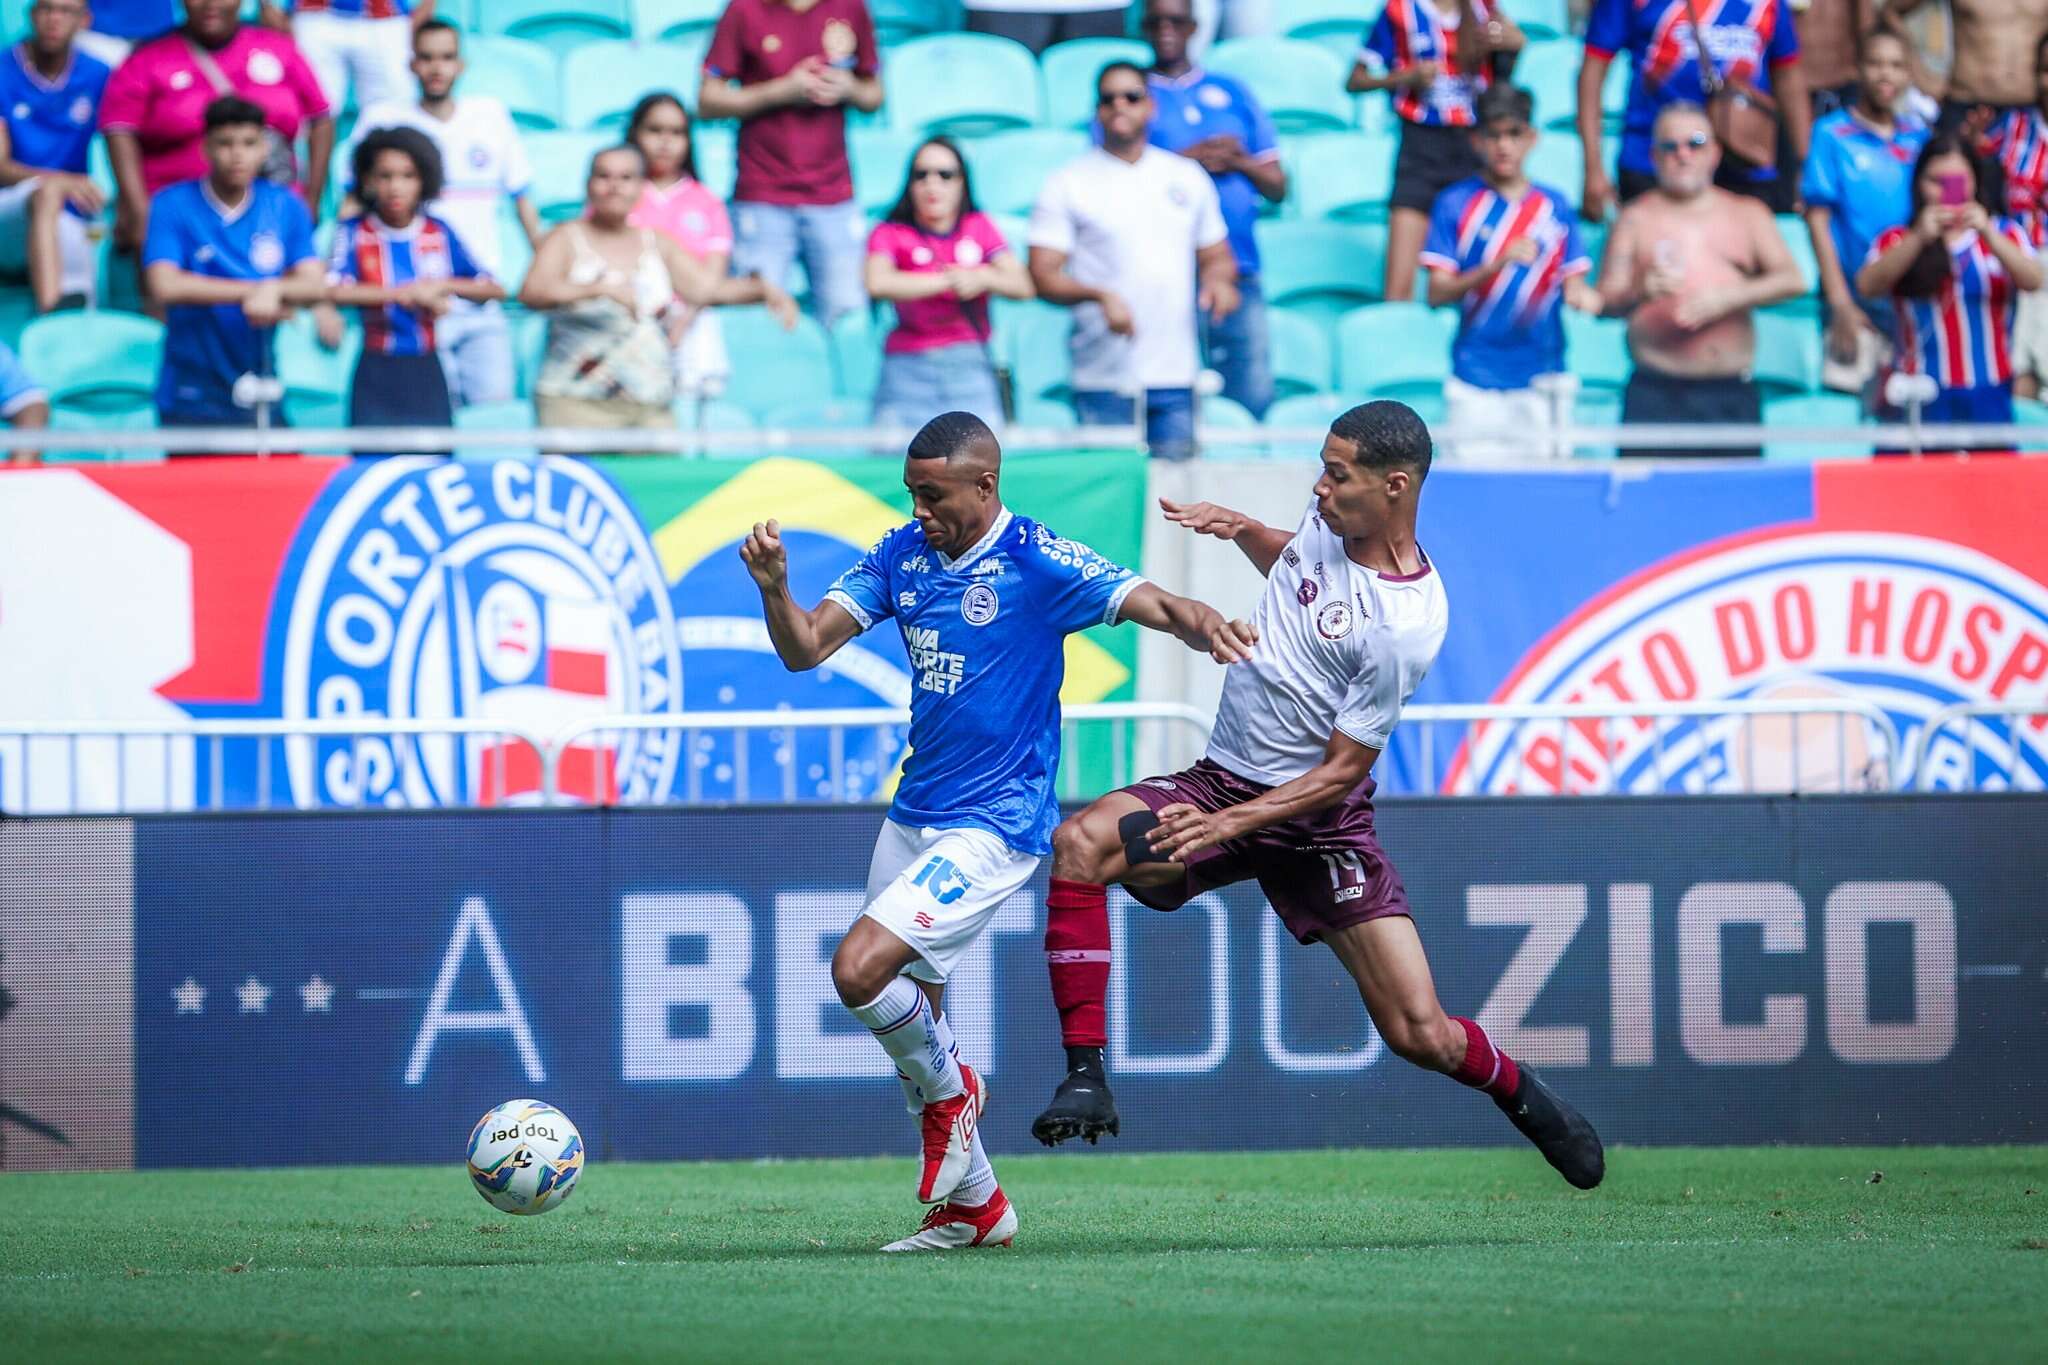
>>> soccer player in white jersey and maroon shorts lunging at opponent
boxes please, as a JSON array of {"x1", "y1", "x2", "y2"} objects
[{"x1": 1032, "y1": 401, "x2": 1606, "y2": 1189}]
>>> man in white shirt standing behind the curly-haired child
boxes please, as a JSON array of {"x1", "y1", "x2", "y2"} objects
[{"x1": 322, "y1": 18, "x2": 541, "y2": 407}]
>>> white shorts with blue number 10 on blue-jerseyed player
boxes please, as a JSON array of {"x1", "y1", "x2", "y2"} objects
[{"x1": 864, "y1": 821, "x2": 1038, "y2": 982}]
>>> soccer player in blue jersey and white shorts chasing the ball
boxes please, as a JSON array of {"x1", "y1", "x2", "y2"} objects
[{"x1": 741, "y1": 411, "x2": 1255, "y2": 1250}]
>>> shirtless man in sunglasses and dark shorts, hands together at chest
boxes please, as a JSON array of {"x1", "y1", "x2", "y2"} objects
[{"x1": 1597, "y1": 102, "x2": 1806, "y2": 456}]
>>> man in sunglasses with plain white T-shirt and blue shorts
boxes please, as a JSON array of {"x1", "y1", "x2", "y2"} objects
[{"x1": 1030, "y1": 61, "x2": 1237, "y2": 458}]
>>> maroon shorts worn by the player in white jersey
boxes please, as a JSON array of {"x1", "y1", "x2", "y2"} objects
[{"x1": 1122, "y1": 759, "x2": 1409, "y2": 943}]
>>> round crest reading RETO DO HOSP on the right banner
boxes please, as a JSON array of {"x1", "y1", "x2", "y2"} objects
[{"x1": 1446, "y1": 532, "x2": 2048, "y2": 794}]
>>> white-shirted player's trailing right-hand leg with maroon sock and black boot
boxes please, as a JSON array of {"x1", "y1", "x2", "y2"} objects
[{"x1": 1323, "y1": 915, "x2": 1606, "y2": 1189}]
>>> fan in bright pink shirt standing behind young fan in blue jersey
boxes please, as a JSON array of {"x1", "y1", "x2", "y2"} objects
[{"x1": 100, "y1": 0, "x2": 334, "y2": 248}]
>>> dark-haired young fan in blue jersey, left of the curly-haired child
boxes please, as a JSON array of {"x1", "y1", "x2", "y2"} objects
[{"x1": 141, "y1": 94, "x2": 328, "y2": 426}]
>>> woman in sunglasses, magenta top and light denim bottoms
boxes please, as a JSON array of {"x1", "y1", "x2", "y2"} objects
[{"x1": 866, "y1": 137, "x2": 1032, "y2": 430}]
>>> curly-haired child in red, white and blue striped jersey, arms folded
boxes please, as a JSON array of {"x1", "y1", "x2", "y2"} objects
[{"x1": 328, "y1": 129, "x2": 506, "y2": 439}]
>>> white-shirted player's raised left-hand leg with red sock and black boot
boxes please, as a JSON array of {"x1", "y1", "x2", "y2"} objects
[{"x1": 1030, "y1": 792, "x2": 1186, "y2": 1146}]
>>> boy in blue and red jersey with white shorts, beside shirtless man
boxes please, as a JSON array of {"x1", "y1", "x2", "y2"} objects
[{"x1": 1421, "y1": 86, "x2": 1602, "y2": 456}]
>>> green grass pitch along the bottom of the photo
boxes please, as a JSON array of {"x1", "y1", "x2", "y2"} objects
[{"x1": 0, "y1": 1148, "x2": 2048, "y2": 1365}]
